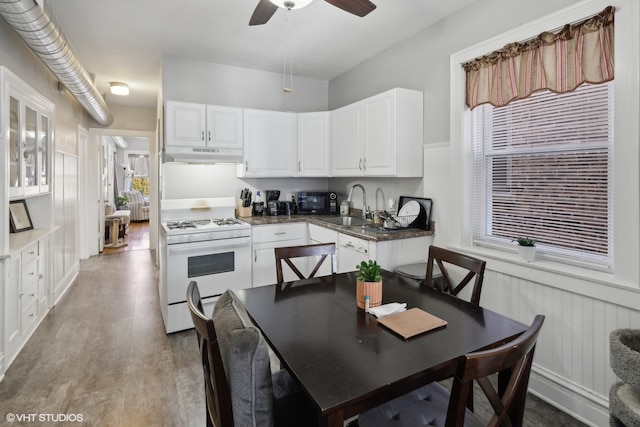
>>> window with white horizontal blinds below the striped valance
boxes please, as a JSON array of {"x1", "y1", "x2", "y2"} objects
[{"x1": 471, "y1": 82, "x2": 613, "y2": 269}]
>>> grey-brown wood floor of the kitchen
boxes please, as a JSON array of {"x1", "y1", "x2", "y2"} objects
[{"x1": 0, "y1": 246, "x2": 583, "y2": 427}]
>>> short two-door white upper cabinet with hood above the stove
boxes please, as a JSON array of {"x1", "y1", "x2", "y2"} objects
[{"x1": 164, "y1": 101, "x2": 243, "y2": 162}]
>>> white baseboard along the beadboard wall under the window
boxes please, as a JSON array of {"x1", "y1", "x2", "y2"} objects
[{"x1": 529, "y1": 366, "x2": 609, "y2": 427}]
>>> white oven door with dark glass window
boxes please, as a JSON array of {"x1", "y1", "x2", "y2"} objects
[{"x1": 167, "y1": 237, "x2": 251, "y2": 305}]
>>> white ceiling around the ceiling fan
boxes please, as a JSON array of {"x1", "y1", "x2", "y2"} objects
[{"x1": 47, "y1": 0, "x2": 474, "y2": 107}]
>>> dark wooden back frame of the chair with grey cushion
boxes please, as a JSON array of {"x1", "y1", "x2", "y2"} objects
[{"x1": 187, "y1": 281, "x2": 233, "y2": 427}]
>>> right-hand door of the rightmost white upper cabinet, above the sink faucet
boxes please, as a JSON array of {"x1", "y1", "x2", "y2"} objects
[{"x1": 363, "y1": 91, "x2": 396, "y2": 176}]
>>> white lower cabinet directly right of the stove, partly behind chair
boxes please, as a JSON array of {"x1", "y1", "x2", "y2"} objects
[{"x1": 251, "y1": 222, "x2": 307, "y2": 287}]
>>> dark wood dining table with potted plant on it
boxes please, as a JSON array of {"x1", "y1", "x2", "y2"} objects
[{"x1": 235, "y1": 271, "x2": 527, "y2": 426}]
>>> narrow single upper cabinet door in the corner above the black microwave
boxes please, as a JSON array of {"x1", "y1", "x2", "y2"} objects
[{"x1": 297, "y1": 112, "x2": 330, "y2": 177}]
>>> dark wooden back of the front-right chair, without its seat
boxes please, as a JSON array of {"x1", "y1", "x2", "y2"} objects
[{"x1": 446, "y1": 314, "x2": 544, "y2": 427}]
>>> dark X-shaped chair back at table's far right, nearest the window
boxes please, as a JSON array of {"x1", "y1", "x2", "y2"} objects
[{"x1": 425, "y1": 245, "x2": 487, "y2": 306}]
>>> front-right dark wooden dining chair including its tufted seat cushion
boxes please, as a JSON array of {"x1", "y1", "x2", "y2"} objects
[{"x1": 358, "y1": 315, "x2": 544, "y2": 427}]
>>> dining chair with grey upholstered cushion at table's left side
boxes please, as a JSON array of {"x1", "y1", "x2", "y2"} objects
[{"x1": 187, "y1": 281, "x2": 316, "y2": 427}]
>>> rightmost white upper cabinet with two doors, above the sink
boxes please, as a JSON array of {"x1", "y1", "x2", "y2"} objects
[{"x1": 331, "y1": 88, "x2": 423, "y2": 177}]
